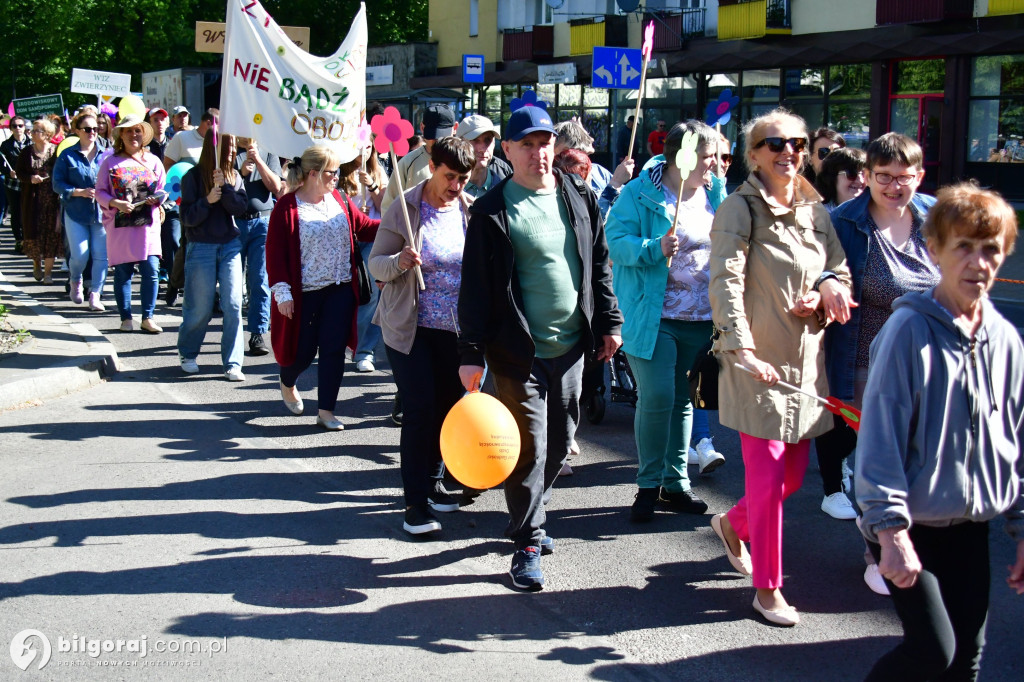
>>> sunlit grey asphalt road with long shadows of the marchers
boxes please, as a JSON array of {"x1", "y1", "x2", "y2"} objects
[{"x1": 6, "y1": 254, "x2": 1024, "y2": 680}]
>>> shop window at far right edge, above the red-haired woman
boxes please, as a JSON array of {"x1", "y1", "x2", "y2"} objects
[{"x1": 967, "y1": 54, "x2": 1024, "y2": 164}]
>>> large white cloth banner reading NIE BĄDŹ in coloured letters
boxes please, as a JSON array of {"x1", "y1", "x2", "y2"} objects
[{"x1": 219, "y1": 0, "x2": 368, "y2": 163}]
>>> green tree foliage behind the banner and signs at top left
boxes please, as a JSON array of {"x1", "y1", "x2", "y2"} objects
[{"x1": 0, "y1": 0, "x2": 427, "y2": 109}]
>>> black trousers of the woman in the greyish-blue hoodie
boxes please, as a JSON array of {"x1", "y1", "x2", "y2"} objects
[{"x1": 866, "y1": 522, "x2": 989, "y2": 682}]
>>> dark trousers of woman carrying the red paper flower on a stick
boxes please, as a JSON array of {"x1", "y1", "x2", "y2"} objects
[{"x1": 384, "y1": 327, "x2": 465, "y2": 507}]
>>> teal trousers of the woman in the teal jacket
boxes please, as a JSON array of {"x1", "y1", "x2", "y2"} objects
[{"x1": 627, "y1": 318, "x2": 712, "y2": 493}]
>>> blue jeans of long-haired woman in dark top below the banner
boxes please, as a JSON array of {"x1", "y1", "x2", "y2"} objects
[{"x1": 178, "y1": 239, "x2": 243, "y2": 371}]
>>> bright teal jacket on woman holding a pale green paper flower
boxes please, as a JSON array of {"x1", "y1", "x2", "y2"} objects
[{"x1": 604, "y1": 164, "x2": 725, "y2": 359}]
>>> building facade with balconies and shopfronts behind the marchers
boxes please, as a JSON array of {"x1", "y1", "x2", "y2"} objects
[{"x1": 411, "y1": 0, "x2": 1024, "y2": 197}]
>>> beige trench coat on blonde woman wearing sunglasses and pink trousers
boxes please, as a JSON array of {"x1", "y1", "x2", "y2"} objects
[{"x1": 710, "y1": 173, "x2": 852, "y2": 443}]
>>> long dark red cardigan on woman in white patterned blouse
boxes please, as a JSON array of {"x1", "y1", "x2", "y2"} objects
[{"x1": 266, "y1": 189, "x2": 381, "y2": 367}]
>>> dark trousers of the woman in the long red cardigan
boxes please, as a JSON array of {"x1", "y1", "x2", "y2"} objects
[{"x1": 280, "y1": 282, "x2": 355, "y2": 412}]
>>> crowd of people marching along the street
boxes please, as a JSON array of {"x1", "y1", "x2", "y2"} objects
[{"x1": 0, "y1": 98, "x2": 1024, "y2": 680}]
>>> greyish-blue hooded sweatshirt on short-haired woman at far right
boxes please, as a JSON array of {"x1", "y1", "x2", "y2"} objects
[{"x1": 856, "y1": 289, "x2": 1024, "y2": 542}]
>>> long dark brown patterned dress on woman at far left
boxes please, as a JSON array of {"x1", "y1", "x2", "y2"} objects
[{"x1": 16, "y1": 144, "x2": 63, "y2": 260}]
